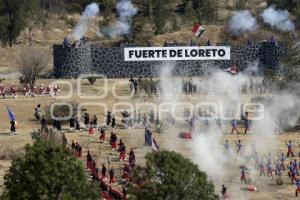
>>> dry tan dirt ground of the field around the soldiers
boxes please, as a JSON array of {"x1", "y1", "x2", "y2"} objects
[{"x1": 0, "y1": 80, "x2": 300, "y2": 200}]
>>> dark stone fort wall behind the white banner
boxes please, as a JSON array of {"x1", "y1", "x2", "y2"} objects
[{"x1": 53, "y1": 42, "x2": 284, "y2": 78}]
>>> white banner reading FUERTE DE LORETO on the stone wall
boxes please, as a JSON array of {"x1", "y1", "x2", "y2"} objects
[{"x1": 124, "y1": 46, "x2": 230, "y2": 61}]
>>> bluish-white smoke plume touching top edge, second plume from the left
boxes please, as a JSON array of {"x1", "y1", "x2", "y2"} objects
[{"x1": 102, "y1": 0, "x2": 138, "y2": 38}]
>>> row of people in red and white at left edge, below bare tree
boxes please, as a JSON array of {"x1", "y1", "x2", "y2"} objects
[{"x1": 0, "y1": 83, "x2": 60, "y2": 98}]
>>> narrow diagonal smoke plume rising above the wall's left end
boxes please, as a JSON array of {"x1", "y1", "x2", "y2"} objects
[{"x1": 71, "y1": 3, "x2": 100, "y2": 40}]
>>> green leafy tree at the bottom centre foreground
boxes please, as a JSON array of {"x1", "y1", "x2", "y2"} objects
[{"x1": 129, "y1": 151, "x2": 218, "y2": 200}]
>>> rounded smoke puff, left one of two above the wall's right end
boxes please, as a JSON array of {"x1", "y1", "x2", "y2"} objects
[{"x1": 228, "y1": 10, "x2": 257, "y2": 36}]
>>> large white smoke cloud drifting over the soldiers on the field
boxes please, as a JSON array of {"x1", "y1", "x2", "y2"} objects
[{"x1": 156, "y1": 62, "x2": 300, "y2": 199}]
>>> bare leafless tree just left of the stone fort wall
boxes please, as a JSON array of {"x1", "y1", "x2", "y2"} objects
[{"x1": 17, "y1": 47, "x2": 49, "y2": 86}]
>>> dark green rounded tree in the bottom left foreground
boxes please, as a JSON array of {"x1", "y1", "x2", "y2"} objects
[{"x1": 2, "y1": 140, "x2": 99, "y2": 200}]
